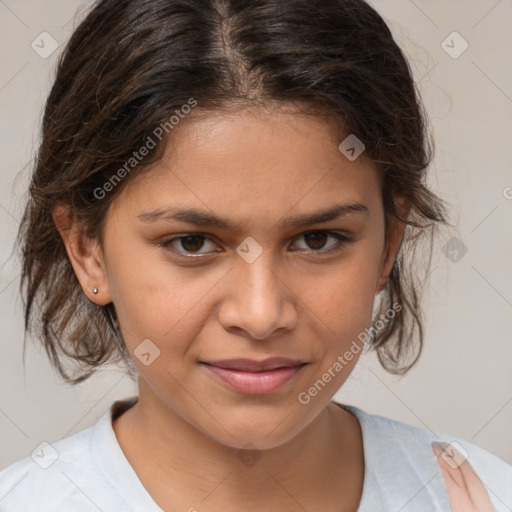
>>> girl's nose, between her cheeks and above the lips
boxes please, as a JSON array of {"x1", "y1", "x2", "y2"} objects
[{"x1": 218, "y1": 254, "x2": 298, "y2": 340}]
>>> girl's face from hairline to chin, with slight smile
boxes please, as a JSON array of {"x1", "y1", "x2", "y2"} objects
[{"x1": 64, "y1": 107, "x2": 399, "y2": 448}]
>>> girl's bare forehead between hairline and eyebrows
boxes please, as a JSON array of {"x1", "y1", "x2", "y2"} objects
[{"x1": 109, "y1": 110, "x2": 380, "y2": 223}]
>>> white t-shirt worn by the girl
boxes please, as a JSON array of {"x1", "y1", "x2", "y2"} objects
[{"x1": 0, "y1": 397, "x2": 512, "y2": 512}]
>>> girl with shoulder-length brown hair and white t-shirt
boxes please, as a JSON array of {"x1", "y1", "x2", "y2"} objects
[{"x1": 0, "y1": 0, "x2": 512, "y2": 512}]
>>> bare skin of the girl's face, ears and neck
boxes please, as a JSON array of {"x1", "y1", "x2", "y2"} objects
[{"x1": 54, "y1": 105, "x2": 408, "y2": 511}]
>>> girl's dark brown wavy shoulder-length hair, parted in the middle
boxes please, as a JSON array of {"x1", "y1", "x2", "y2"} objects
[{"x1": 19, "y1": 0, "x2": 446, "y2": 384}]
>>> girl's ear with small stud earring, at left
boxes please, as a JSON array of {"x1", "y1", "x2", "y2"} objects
[{"x1": 52, "y1": 206, "x2": 112, "y2": 306}]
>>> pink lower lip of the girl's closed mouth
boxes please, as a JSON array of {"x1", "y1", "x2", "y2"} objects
[{"x1": 202, "y1": 364, "x2": 302, "y2": 395}]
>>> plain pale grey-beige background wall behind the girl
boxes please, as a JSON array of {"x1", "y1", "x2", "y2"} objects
[{"x1": 0, "y1": 0, "x2": 512, "y2": 468}]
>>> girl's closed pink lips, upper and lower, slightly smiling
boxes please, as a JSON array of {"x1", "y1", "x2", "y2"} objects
[{"x1": 201, "y1": 357, "x2": 305, "y2": 395}]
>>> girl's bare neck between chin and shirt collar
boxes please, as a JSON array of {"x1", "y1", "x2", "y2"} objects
[{"x1": 114, "y1": 382, "x2": 364, "y2": 511}]
